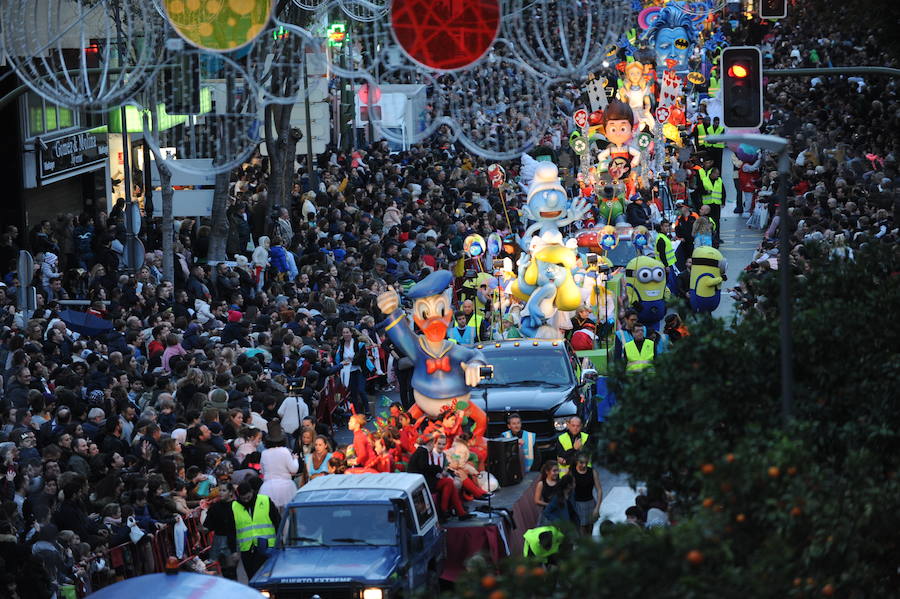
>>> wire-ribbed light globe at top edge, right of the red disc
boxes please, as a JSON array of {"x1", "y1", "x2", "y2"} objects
[{"x1": 503, "y1": 0, "x2": 631, "y2": 79}]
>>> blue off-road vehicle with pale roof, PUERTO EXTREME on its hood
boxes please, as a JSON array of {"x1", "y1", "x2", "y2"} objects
[{"x1": 250, "y1": 473, "x2": 446, "y2": 599}]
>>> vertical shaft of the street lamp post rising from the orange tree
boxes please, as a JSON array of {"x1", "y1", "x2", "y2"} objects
[{"x1": 777, "y1": 146, "x2": 794, "y2": 423}]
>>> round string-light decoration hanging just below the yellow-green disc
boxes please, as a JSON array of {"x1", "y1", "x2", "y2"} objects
[{"x1": 141, "y1": 50, "x2": 261, "y2": 174}]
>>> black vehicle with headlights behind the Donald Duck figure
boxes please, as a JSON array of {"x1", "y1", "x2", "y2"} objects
[{"x1": 471, "y1": 339, "x2": 596, "y2": 467}]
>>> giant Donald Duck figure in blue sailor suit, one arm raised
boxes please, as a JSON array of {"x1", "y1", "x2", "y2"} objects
[{"x1": 377, "y1": 270, "x2": 487, "y2": 437}]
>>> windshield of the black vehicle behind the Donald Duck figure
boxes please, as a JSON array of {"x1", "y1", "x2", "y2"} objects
[{"x1": 481, "y1": 347, "x2": 573, "y2": 387}]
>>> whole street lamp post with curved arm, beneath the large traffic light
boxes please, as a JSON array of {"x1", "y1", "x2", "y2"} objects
[{"x1": 707, "y1": 133, "x2": 794, "y2": 423}]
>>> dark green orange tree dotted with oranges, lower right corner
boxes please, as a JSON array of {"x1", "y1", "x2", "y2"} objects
[{"x1": 453, "y1": 244, "x2": 900, "y2": 599}]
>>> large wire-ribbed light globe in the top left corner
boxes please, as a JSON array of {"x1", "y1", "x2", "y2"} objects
[{"x1": 0, "y1": 0, "x2": 165, "y2": 111}]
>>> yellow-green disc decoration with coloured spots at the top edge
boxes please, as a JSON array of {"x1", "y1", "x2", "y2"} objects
[{"x1": 163, "y1": 0, "x2": 273, "y2": 52}]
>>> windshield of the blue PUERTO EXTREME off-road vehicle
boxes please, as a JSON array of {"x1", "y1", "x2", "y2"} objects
[{"x1": 284, "y1": 504, "x2": 398, "y2": 547}]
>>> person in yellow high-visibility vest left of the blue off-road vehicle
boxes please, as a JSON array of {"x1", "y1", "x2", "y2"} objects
[{"x1": 231, "y1": 482, "x2": 281, "y2": 579}]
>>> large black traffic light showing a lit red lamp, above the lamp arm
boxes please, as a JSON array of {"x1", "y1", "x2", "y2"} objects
[{"x1": 720, "y1": 46, "x2": 762, "y2": 129}]
